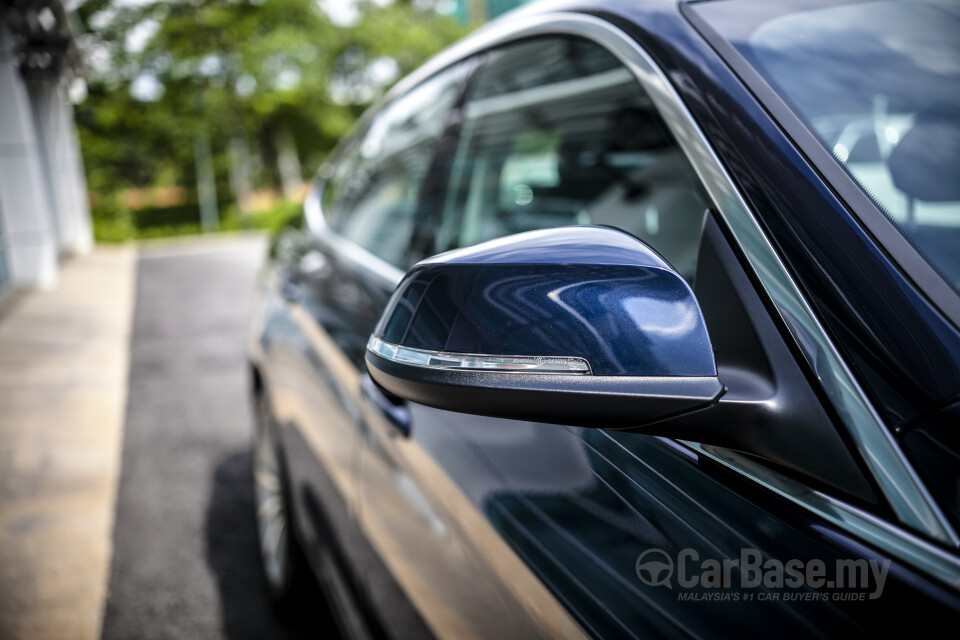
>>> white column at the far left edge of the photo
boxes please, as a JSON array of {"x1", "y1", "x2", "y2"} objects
[{"x1": 0, "y1": 23, "x2": 57, "y2": 288}]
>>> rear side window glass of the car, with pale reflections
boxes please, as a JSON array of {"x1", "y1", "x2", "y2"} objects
[{"x1": 328, "y1": 67, "x2": 463, "y2": 267}]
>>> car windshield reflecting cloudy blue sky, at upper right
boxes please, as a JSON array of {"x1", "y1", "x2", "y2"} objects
[{"x1": 696, "y1": 0, "x2": 960, "y2": 291}]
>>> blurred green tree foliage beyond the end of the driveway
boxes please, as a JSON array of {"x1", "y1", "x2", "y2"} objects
[{"x1": 75, "y1": 0, "x2": 465, "y2": 235}]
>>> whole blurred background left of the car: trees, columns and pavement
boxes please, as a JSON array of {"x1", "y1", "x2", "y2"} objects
[{"x1": 0, "y1": 0, "x2": 523, "y2": 640}]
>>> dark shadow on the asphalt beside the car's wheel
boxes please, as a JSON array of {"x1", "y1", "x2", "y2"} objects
[{"x1": 204, "y1": 451, "x2": 339, "y2": 640}]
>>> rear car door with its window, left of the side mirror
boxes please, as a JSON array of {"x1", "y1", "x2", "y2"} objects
[{"x1": 268, "y1": 61, "x2": 468, "y2": 633}]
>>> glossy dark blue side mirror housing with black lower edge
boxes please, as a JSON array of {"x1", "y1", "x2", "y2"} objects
[{"x1": 366, "y1": 226, "x2": 724, "y2": 428}]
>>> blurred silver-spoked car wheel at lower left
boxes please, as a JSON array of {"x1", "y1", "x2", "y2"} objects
[{"x1": 253, "y1": 394, "x2": 306, "y2": 609}]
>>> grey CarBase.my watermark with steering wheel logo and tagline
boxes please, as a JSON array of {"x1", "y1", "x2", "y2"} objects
[{"x1": 636, "y1": 548, "x2": 890, "y2": 601}]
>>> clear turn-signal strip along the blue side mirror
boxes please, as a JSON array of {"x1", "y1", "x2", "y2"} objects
[{"x1": 367, "y1": 336, "x2": 593, "y2": 375}]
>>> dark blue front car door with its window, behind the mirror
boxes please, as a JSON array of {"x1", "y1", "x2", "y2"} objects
[{"x1": 360, "y1": 17, "x2": 958, "y2": 637}]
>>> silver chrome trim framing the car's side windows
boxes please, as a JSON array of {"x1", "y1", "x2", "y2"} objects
[{"x1": 310, "y1": 13, "x2": 960, "y2": 556}]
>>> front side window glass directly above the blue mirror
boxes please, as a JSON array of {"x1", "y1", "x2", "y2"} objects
[{"x1": 435, "y1": 37, "x2": 708, "y2": 282}]
